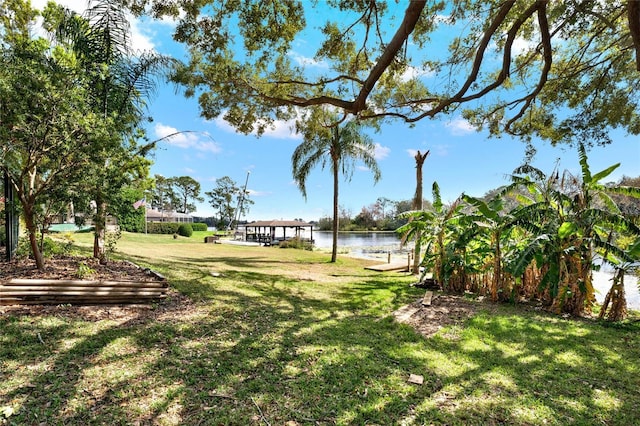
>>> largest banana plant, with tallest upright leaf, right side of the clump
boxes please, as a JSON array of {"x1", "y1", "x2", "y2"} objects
[{"x1": 508, "y1": 144, "x2": 640, "y2": 315}]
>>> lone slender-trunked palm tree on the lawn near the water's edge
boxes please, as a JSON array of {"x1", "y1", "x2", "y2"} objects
[{"x1": 291, "y1": 121, "x2": 381, "y2": 262}]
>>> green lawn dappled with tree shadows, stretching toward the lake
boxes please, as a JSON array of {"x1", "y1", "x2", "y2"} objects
[{"x1": 0, "y1": 233, "x2": 640, "y2": 425}]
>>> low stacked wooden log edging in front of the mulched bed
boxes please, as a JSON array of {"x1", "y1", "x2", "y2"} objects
[{"x1": 0, "y1": 273, "x2": 169, "y2": 305}]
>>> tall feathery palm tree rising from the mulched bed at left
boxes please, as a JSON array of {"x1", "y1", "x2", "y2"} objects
[{"x1": 49, "y1": 0, "x2": 174, "y2": 260}]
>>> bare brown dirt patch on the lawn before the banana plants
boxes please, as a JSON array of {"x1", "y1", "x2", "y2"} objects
[{"x1": 393, "y1": 295, "x2": 480, "y2": 337}]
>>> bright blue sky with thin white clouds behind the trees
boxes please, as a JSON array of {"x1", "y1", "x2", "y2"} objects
[{"x1": 32, "y1": 0, "x2": 640, "y2": 220}]
